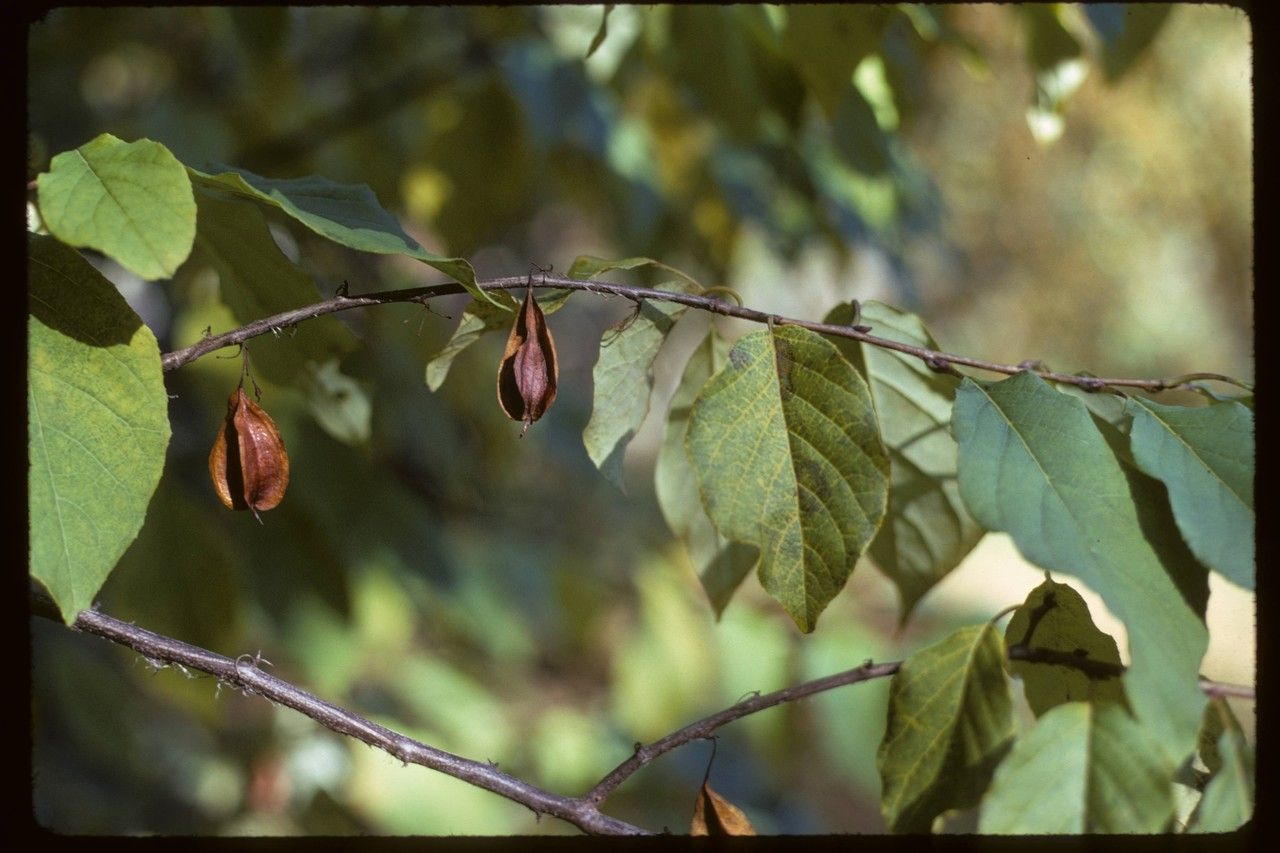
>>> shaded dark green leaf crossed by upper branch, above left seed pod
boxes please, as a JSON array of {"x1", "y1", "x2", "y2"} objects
[{"x1": 196, "y1": 192, "x2": 358, "y2": 384}]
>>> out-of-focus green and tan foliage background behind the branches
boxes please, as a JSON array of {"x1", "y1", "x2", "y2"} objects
[{"x1": 28, "y1": 4, "x2": 1253, "y2": 835}]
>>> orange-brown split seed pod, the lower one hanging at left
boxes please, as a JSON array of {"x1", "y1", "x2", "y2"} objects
[{"x1": 209, "y1": 388, "x2": 289, "y2": 523}]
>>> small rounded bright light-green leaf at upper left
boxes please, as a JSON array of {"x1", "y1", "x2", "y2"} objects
[{"x1": 36, "y1": 133, "x2": 196, "y2": 279}]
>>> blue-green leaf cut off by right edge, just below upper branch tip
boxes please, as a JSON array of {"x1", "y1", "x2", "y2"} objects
[{"x1": 1125, "y1": 397, "x2": 1254, "y2": 589}]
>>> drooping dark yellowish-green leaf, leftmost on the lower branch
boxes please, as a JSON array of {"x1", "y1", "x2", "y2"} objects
[{"x1": 876, "y1": 624, "x2": 1014, "y2": 833}]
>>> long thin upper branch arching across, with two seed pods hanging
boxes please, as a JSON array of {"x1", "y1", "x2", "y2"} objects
[{"x1": 161, "y1": 274, "x2": 1248, "y2": 391}]
